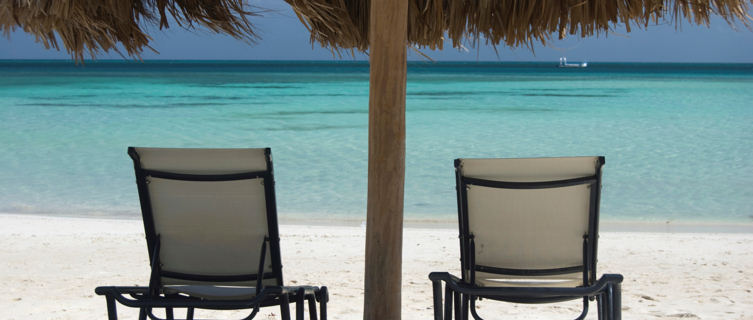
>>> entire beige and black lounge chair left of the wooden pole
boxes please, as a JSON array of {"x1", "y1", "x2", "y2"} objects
[{"x1": 95, "y1": 147, "x2": 328, "y2": 319}]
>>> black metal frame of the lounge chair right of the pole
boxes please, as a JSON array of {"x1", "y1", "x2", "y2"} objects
[{"x1": 429, "y1": 157, "x2": 623, "y2": 320}]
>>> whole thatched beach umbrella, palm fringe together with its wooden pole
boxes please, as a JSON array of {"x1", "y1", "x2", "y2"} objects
[{"x1": 0, "y1": 0, "x2": 753, "y2": 319}]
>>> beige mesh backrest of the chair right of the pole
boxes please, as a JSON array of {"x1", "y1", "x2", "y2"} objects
[{"x1": 456, "y1": 157, "x2": 603, "y2": 287}]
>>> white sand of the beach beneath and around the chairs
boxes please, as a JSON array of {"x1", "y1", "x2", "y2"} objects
[{"x1": 0, "y1": 214, "x2": 753, "y2": 320}]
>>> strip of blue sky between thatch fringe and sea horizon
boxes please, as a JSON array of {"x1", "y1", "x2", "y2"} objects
[{"x1": 0, "y1": 0, "x2": 753, "y2": 63}]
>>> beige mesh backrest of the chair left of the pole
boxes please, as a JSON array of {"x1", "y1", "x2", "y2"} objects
[{"x1": 129, "y1": 148, "x2": 282, "y2": 286}]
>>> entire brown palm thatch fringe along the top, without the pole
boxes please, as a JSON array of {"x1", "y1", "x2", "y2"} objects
[{"x1": 0, "y1": 0, "x2": 753, "y2": 60}]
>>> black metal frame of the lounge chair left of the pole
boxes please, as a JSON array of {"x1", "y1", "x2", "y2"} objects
[{"x1": 95, "y1": 147, "x2": 329, "y2": 320}]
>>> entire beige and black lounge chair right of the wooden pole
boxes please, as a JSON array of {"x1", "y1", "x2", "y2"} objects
[{"x1": 429, "y1": 157, "x2": 622, "y2": 319}]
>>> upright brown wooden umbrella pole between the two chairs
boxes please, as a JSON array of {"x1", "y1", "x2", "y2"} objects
[{"x1": 363, "y1": 0, "x2": 408, "y2": 320}]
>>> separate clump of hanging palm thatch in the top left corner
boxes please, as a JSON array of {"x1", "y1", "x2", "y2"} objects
[{"x1": 0, "y1": 0, "x2": 255, "y2": 61}]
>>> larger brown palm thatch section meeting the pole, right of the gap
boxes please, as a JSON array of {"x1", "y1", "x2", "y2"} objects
[{"x1": 285, "y1": 0, "x2": 753, "y2": 51}]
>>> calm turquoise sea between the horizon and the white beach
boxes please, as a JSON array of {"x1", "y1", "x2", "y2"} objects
[{"x1": 0, "y1": 61, "x2": 753, "y2": 223}]
